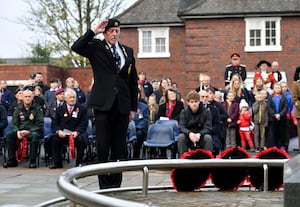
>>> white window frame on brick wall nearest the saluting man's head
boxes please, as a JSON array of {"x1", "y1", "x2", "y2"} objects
[{"x1": 137, "y1": 27, "x2": 171, "y2": 58}]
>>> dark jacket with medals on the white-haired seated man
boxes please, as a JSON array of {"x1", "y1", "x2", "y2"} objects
[{"x1": 53, "y1": 103, "x2": 88, "y2": 134}]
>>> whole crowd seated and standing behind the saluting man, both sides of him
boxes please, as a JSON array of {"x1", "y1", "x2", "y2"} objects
[{"x1": 0, "y1": 53, "x2": 298, "y2": 169}]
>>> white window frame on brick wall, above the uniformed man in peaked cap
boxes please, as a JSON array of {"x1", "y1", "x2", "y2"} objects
[{"x1": 245, "y1": 17, "x2": 282, "y2": 52}]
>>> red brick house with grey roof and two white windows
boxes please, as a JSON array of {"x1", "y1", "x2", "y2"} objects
[{"x1": 118, "y1": 0, "x2": 300, "y2": 96}]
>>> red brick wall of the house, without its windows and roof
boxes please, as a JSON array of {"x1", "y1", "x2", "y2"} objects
[{"x1": 121, "y1": 17, "x2": 300, "y2": 95}]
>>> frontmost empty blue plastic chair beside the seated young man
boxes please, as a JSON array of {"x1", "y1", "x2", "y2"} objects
[{"x1": 143, "y1": 124, "x2": 175, "y2": 159}]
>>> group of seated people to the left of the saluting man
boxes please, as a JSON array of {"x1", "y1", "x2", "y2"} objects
[{"x1": 0, "y1": 73, "x2": 88, "y2": 169}]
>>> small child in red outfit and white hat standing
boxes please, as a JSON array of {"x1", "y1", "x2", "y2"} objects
[{"x1": 237, "y1": 100, "x2": 255, "y2": 152}]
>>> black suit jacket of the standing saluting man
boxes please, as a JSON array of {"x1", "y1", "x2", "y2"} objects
[{"x1": 72, "y1": 30, "x2": 138, "y2": 114}]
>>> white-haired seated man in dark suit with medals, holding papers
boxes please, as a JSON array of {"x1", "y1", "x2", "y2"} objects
[{"x1": 50, "y1": 88, "x2": 88, "y2": 169}]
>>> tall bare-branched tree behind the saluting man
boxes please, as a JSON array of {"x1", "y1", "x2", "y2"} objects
[{"x1": 21, "y1": 0, "x2": 124, "y2": 67}]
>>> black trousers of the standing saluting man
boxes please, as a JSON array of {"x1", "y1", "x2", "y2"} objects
[{"x1": 94, "y1": 104, "x2": 129, "y2": 189}]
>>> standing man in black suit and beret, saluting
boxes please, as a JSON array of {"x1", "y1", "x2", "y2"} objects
[{"x1": 72, "y1": 19, "x2": 138, "y2": 189}]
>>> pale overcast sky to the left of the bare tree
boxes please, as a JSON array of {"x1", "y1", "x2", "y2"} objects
[{"x1": 0, "y1": 0, "x2": 135, "y2": 59}]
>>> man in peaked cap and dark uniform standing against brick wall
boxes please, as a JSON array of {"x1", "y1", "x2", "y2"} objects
[{"x1": 224, "y1": 53, "x2": 247, "y2": 86}]
